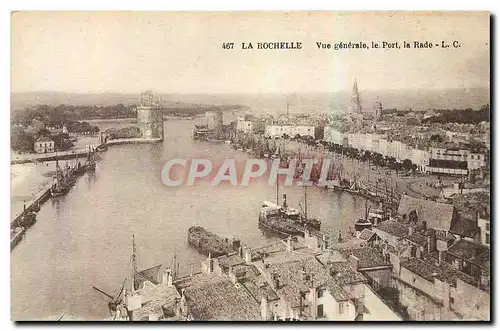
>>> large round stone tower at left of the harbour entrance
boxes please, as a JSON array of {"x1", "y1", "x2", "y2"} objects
[{"x1": 137, "y1": 91, "x2": 163, "y2": 139}]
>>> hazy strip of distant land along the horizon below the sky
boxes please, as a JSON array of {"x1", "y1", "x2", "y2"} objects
[{"x1": 11, "y1": 86, "x2": 490, "y2": 114}]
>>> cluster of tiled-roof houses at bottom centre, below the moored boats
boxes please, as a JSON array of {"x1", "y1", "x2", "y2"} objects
[{"x1": 117, "y1": 238, "x2": 401, "y2": 321}]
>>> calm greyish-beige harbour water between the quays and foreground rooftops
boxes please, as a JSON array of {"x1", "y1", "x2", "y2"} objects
[{"x1": 11, "y1": 120, "x2": 365, "y2": 320}]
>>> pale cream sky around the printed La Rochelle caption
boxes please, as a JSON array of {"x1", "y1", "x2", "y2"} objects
[{"x1": 11, "y1": 12, "x2": 490, "y2": 93}]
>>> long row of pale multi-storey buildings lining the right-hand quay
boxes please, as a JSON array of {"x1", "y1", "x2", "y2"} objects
[{"x1": 324, "y1": 126, "x2": 489, "y2": 175}]
